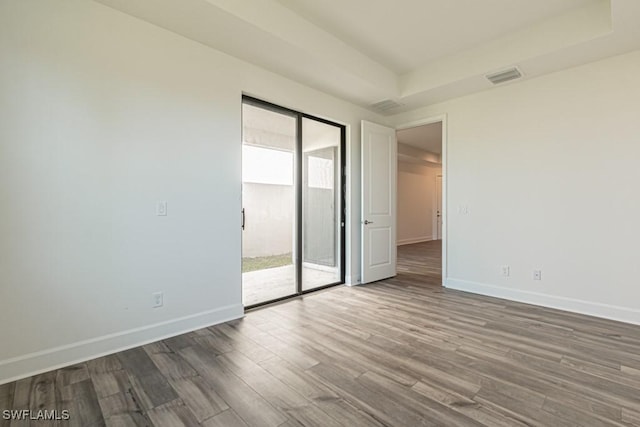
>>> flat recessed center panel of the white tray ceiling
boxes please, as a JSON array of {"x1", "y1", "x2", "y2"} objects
[{"x1": 279, "y1": 0, "x2": 592, "y2": 74}]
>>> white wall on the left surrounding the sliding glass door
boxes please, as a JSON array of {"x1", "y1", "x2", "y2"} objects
[{"x1": 0, "y1": 0, "x2": 381, "y2": 382}]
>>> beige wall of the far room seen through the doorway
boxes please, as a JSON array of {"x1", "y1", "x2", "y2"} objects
[{"x1": 398, "y1": 161, "x2": 442, "y2": 245}]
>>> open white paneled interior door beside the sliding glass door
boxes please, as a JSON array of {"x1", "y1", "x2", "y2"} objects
[{"x1": 361, "y1": 121, "x2": 398, "y2": 283}]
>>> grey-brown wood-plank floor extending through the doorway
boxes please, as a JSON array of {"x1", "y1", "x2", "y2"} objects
[{"x1": 0, "y1": 242, "x2": 640, "y2": 427}]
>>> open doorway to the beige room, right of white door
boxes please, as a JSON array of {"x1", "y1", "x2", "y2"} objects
[{"x1": 396, "y1": 119, "x2": 444, "y2": 286}]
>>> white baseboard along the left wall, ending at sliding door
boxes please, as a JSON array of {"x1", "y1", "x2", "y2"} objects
[{"x1": 0, "y1": 304, "x2": 244, "y2": 385}]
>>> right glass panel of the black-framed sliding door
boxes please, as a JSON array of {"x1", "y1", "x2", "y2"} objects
[{"x1": 302, "y1": 117, "x2": 342, "y2": 291}]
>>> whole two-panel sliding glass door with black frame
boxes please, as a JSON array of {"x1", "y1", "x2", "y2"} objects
[{"x1": 242, "y1": 96, "x2": 346, "y2": 308}]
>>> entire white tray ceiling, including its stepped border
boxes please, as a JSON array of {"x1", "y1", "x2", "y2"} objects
[{"x1": 95, "y1": 0, "x2": 640, "y2": 115}]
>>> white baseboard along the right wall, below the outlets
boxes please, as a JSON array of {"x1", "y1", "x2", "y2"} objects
[{"x1": 444, "y1": 278, "x2": 640, "y2": 325}]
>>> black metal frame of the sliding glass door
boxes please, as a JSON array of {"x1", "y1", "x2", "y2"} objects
[{"x1": 242, "y1": 95, "x2": 347, "y2": 310}]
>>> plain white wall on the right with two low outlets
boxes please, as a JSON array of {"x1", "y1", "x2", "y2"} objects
[{"x1": 394, "y1": 51, "x2": 640, "y2": 323}]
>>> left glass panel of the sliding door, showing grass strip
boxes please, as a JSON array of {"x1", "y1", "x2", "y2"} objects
[{"x1": 242, "y1": 103, "x2": 298, "y2": 306}]
